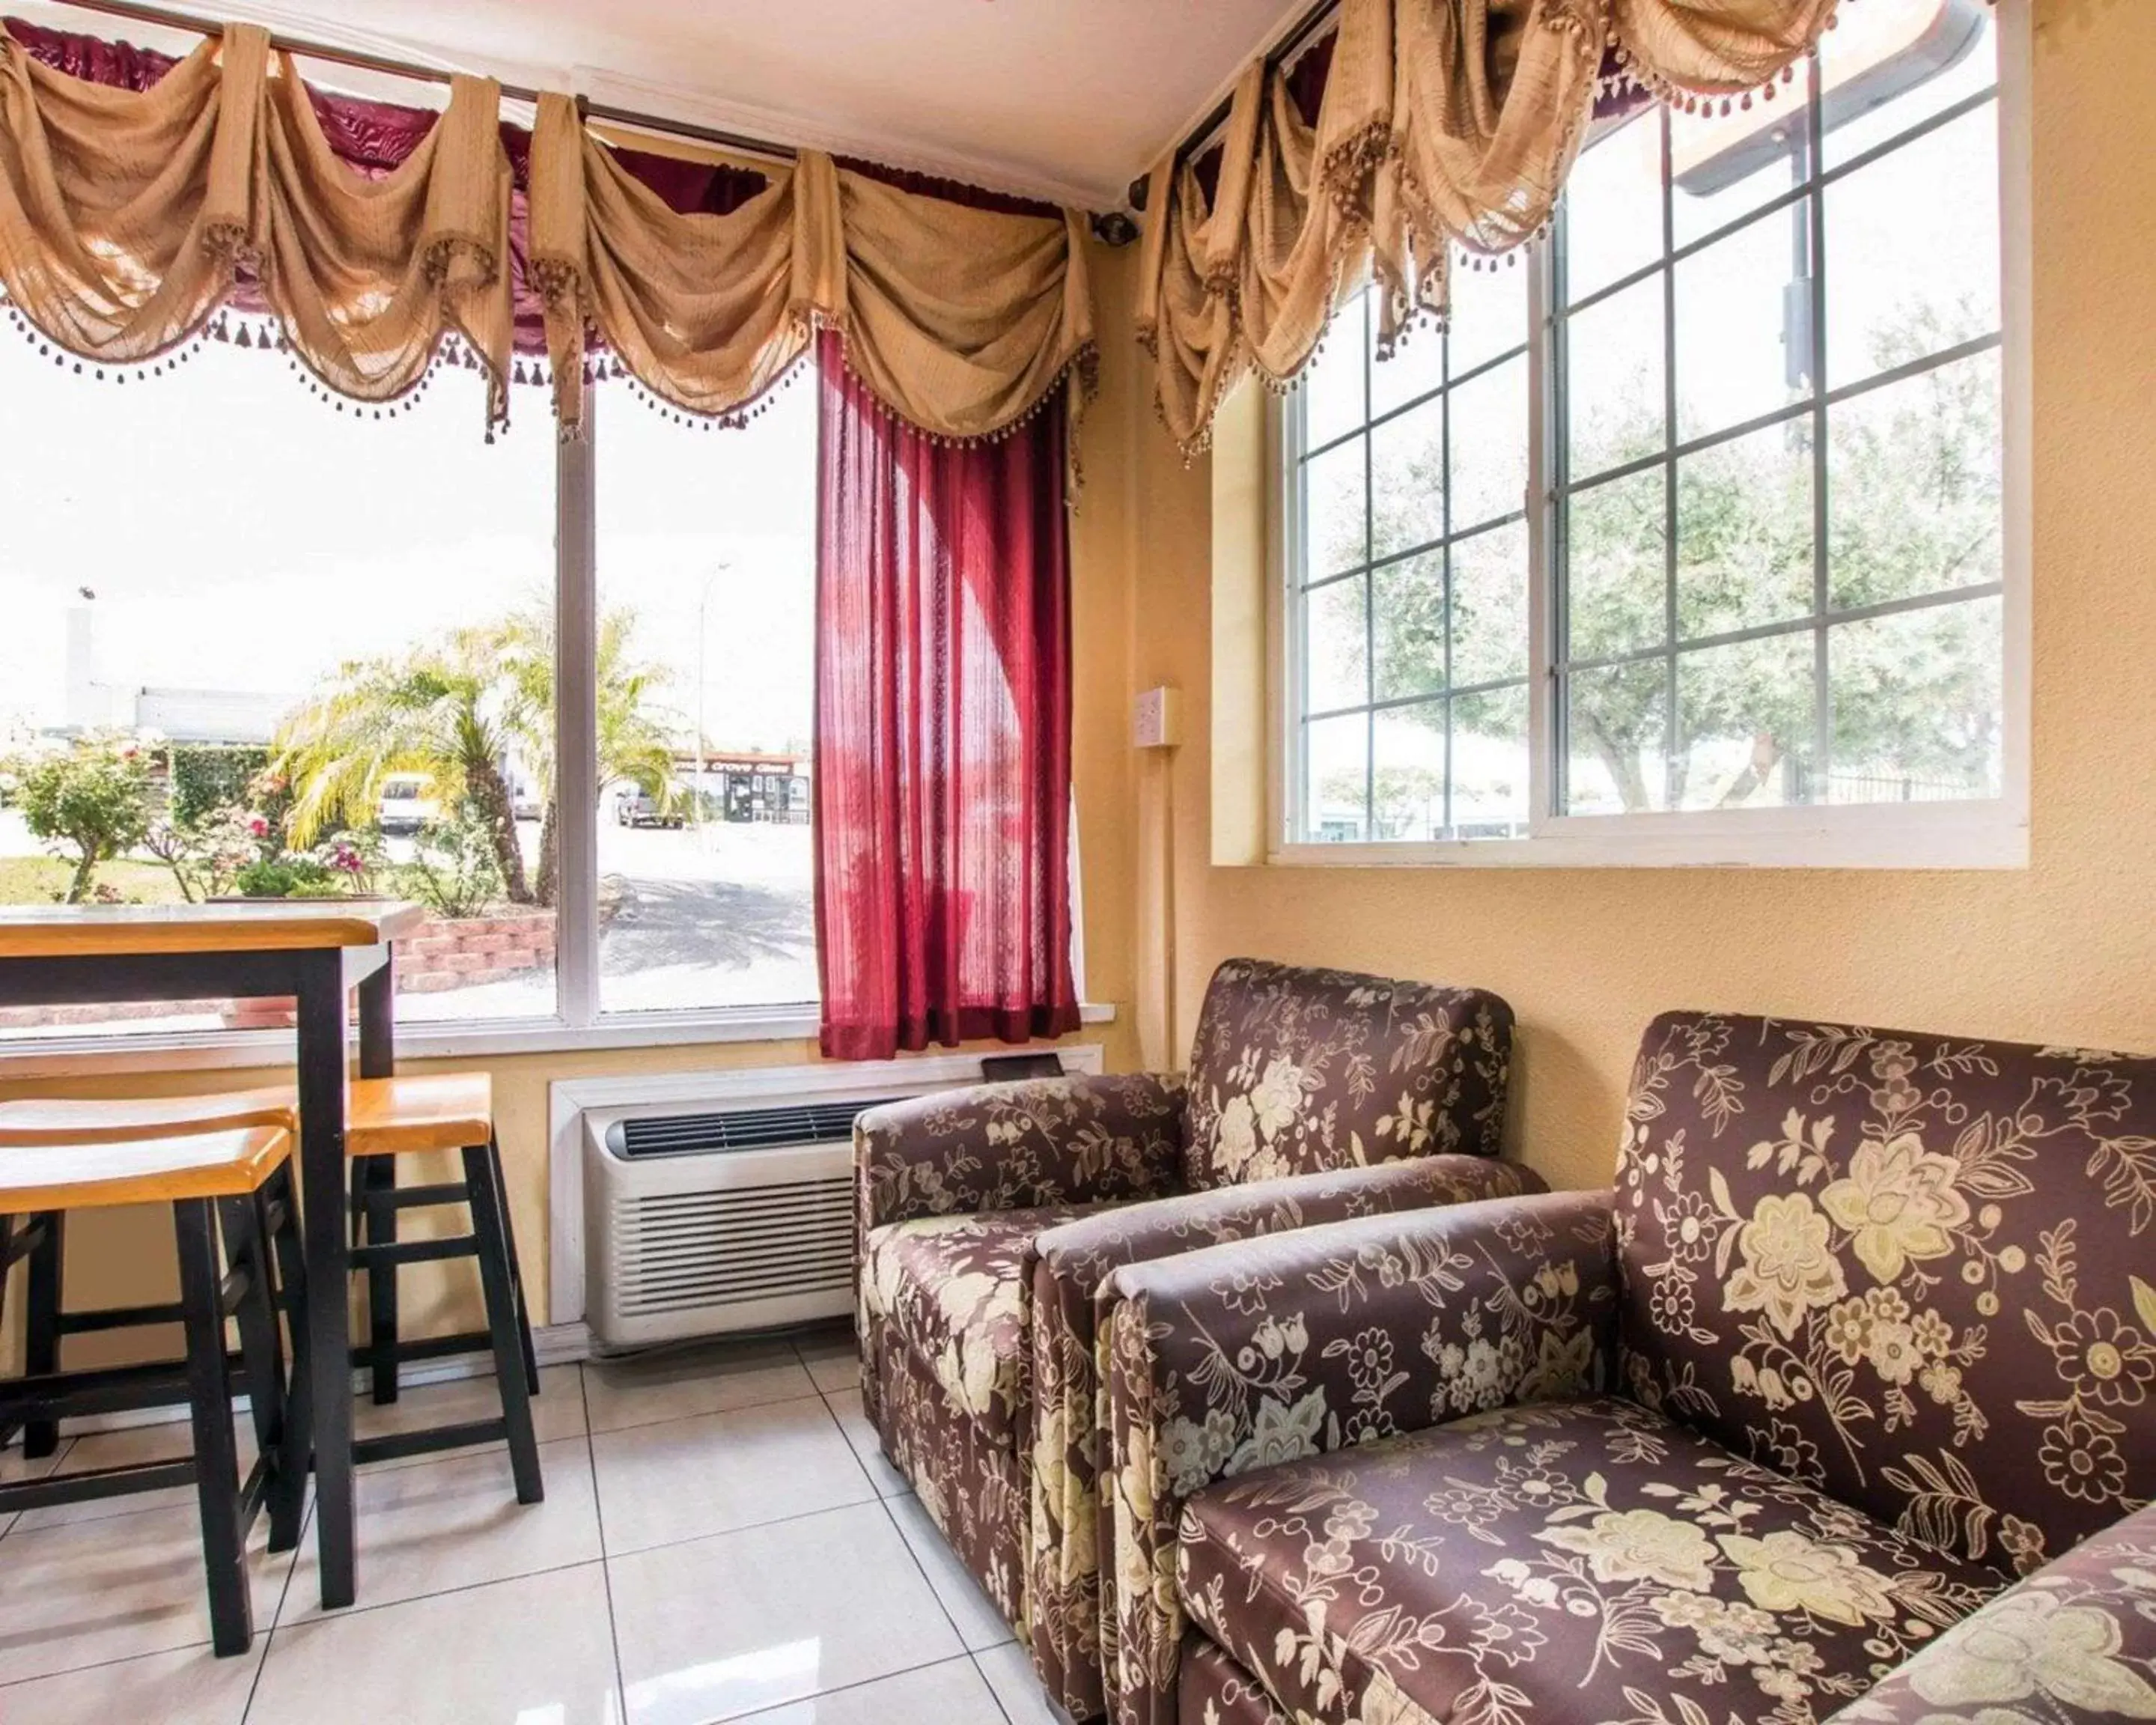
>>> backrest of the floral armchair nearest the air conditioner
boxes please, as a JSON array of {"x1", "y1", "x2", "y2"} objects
[{"x1": 1184, "y1": 958, "x2": 1511, "y2": 1190}]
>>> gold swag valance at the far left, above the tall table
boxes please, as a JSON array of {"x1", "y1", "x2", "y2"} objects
[{"x1": 0, "y1": 24, "x2": 511, "y2": 422}]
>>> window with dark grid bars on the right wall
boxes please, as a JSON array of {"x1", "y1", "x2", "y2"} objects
[{"x1": 1283, "y1": 0, "x2": 2024, "y2": 862}]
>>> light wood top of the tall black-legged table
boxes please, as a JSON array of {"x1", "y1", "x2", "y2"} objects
[{"x1": 0, "y1": 899, "x2": 427, "y2": 960}]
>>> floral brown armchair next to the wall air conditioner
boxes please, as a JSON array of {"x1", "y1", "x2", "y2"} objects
[{"x1": 856, "y1": 960, "x2": 1541, "y2": 1718}]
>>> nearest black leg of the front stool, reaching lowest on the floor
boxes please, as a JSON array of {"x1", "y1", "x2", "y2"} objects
[{"x1": 172, "y1": 1199, "x2": 255, "y2": 1658}]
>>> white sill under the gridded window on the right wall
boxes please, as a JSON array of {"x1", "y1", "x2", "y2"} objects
[{"x1": 1266, "y1": 802, "x2": 2029, "y2": 869}]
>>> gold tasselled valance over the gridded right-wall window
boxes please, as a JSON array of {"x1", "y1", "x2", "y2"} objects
[{"x1": 1136, "y1": 0, "x2": 1871, "y2": 455}]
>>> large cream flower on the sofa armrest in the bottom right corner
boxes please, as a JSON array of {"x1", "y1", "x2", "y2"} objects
[{"x1": 1908, "y1": 1587, "x2": 2156, "y2": 1718}]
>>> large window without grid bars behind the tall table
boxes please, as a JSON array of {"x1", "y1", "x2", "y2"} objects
[{"x1": 0, "y1": 321, "x2": 817, "y2": 1046}]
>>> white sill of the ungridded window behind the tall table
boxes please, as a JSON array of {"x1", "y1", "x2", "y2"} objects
[{"x1": 0, "y1": 1003, "x2": 1115, "y2": 1080}]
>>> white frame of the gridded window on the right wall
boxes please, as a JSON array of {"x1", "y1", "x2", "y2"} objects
[{"x1": 1266, "y1": 4, "x2": 2033, "y2": 869}]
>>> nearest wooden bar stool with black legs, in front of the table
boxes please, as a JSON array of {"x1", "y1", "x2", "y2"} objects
[{"x1": 0, "y1": 1104, "x2": 313, "y2": 1656}]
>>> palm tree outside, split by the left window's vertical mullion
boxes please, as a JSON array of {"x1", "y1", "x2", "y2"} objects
[{"x1": 500, "y1": 608, "x2": 677, "y2": 904}]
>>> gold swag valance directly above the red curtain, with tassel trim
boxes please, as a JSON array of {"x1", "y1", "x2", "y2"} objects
[{"x1": 530, "y1": 95, "x2": 1093, "y2": 440}]
